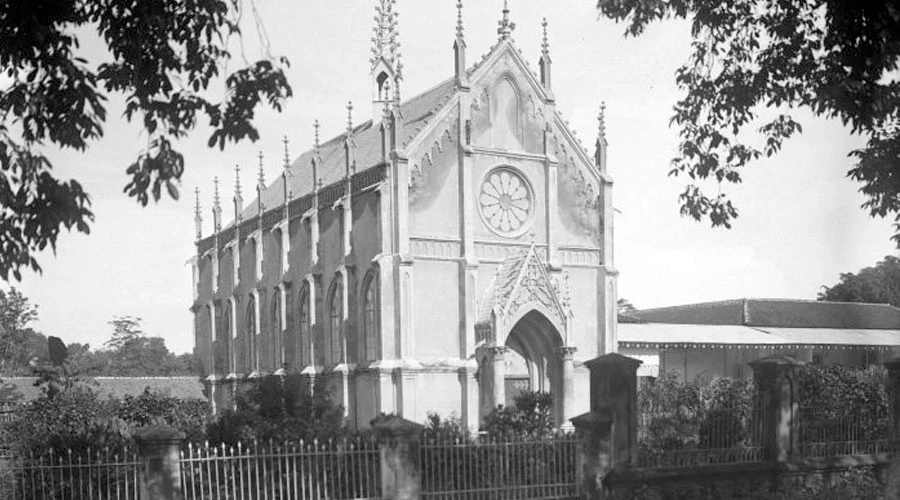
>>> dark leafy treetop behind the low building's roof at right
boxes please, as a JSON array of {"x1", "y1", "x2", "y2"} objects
[{"x1": 818, "y1": 255, "x2": 900, "y2": 307}]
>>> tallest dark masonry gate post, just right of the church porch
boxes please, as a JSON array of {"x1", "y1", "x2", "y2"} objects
[{"x1": 584, "y1": 353, "x2": 642, "y2": 466}]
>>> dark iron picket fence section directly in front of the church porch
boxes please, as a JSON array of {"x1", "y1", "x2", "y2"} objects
[{"x1": 419, "y1": 434, "x2": 578, "y2": 500}]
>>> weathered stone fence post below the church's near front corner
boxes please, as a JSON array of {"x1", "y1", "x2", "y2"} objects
[{"x1": 372, "y1": 415, "x2": 422, "y2": 500}]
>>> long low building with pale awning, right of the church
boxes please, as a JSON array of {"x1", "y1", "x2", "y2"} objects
[{"x1": 618, "y1": 299, "x2": 900, "y2": 380}]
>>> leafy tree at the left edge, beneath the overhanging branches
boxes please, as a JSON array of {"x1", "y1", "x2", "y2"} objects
[{"x1": 0, "y1": 287, "x2": 47, "y2": 375}]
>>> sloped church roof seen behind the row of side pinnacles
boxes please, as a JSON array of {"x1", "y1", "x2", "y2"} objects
[{"x1": 231, "y1": 78, "x2": 456, "y2": 225}]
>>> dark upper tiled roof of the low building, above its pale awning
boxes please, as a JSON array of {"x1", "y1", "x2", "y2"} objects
[{"x1": 630, "y1": 299, "x2": 900, "y2": 329}]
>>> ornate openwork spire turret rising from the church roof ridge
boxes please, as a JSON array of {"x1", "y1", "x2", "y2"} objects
[{"x1": 370, "y1": 0, "x2": 401, "y2": 120}]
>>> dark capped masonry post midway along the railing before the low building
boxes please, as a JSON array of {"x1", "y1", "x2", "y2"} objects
[{"x1": 749, "y1": 355, "x2": 805, "y2": 462}]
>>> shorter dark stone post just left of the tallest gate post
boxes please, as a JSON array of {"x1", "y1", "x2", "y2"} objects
[{"x1": 572, "y1": 409, "x2": 613, "y2": 500}]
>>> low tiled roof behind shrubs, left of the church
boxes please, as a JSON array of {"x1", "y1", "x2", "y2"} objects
[{"x1": 0, "y1": 377, "x2": 206, "y2": 403}]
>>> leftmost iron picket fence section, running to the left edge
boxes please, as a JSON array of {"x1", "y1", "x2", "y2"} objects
[{"x1": 0, "y1": 448, "x2": 142, "y2": 500}]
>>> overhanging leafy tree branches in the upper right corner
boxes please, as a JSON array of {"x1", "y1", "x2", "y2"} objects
[{"x1": 597, "y1": 0, "x2": 900, "y2": 238}]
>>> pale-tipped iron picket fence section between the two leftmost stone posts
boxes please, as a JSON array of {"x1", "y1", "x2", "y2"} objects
[{"x1": 181, "y1": 438, "x2": 381, "y2": 500}]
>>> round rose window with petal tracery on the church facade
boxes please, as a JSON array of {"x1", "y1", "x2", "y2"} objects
[{"x1": 478, "y1": 168, "x2": 533, "y2": 236}]
